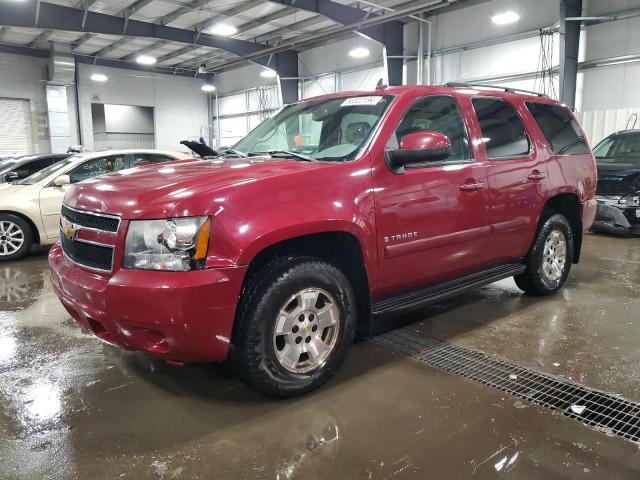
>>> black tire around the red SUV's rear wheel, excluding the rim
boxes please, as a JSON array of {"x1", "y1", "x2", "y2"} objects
[{"x1": 513, "y1": 213, "x2": 573, "y2": 295}]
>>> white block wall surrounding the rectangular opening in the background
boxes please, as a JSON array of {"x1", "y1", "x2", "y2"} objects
[{"x1": 78, "y1": 64, "x2": 208, "y2": 150}]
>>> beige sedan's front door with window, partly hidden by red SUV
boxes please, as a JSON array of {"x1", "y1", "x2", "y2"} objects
[{"x1": 40, "y1": 155, "x2": 128, "y2": 241}]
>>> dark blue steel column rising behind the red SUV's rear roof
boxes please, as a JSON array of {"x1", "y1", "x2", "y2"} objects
[{"x1": 559, "y1": 0, "x2": 582, "y2": 107}]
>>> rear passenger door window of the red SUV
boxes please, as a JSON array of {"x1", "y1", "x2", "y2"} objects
[{"x1": 472, "y1": 98, "x2": 529, "y2": 160}]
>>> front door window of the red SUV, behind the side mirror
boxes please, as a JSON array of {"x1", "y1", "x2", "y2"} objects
[{"x1": 388, "y1": 95, "x2": 471, "y2": 161}]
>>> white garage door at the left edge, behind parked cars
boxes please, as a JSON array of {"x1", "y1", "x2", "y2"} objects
[{"x1": 0, "y1": 98, "x2": 32, "y2": 154}]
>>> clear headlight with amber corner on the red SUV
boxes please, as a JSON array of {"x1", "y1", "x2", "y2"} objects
[{"x1": 123, "y1": 217, "x2": 211, "y2": 272}]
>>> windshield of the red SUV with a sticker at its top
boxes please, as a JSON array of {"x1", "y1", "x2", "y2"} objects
[{"x1": 233, "y1": 95, "x2": 393, "y2": 161}]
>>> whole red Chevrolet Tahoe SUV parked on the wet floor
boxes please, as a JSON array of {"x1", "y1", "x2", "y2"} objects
[{"x1": 49, "y1": 84, "x2": 597, "y2": 397}]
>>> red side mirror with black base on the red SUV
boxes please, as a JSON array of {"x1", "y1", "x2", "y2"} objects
[{"x1": 387, "y1": 132, "x2": 451, "y2": 172}]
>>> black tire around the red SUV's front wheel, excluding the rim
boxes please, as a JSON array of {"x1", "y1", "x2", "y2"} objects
[{"x1": 230, "y1": 257, "x2": 357, "y2": 398}]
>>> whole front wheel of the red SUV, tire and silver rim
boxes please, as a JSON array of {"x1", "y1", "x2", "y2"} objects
[{"x1": 230, "y1": 257, "x2": 356, "y2": 398}]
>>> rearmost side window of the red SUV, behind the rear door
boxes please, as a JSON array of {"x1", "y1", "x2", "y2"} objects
[{"x1": 527, "y1": 102, "x2": 589, "y2": 155}]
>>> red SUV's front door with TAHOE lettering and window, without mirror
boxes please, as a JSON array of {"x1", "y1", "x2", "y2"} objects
[{"x1": 373, "y1": 95, "x2": 491, "y2": 296}]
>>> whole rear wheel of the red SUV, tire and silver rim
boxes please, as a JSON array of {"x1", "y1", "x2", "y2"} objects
[{"x1": 514, "y1": 214, "x2": 573, "y2": 295}]
